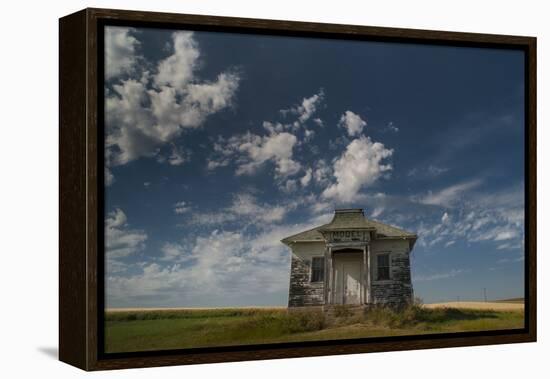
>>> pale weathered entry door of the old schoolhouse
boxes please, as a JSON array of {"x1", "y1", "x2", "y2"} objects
[{"x1": 333, "y1": 259, "x2": 361, "y2": 304}]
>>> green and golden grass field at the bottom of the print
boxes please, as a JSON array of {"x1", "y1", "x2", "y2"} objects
[{"x1": 105, "y1": 306, "x2": 524, "y2": 352}]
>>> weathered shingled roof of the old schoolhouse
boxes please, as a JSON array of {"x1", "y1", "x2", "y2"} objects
[{"x1": 281, "y1": 209, "x2": 416, "y2": 245}]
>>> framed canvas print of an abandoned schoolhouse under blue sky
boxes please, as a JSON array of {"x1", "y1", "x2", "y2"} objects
[{"x1": 59, "y1": 9, "x2": 536, "y2": 370}]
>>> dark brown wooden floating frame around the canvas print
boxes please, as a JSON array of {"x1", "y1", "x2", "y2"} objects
[{"x1": 59, "y1": 8, "x2": 536, "y2": 370}]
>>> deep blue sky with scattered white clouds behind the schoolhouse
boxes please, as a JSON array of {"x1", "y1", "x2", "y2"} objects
[{"x1": 105, "y1": 27, "x2": 524, "y2": 307}]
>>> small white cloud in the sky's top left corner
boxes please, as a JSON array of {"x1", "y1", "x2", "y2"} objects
[{"x1": 105, "y1": 26, "x2": 140, "y2": 80}]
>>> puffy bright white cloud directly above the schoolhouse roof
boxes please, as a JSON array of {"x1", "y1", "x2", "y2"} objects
[{"x1": 323, "y1": 136, "x2": 393, "y2": 203}]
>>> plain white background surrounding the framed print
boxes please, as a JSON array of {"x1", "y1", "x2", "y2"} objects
[{"x1": 0, "y1": 0, "x2": 550, "y2": 379}]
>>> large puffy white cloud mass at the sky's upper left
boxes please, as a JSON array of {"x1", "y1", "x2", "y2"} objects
[{"x1": 105, "y1": 32, "x2": 240, "y2": 171}]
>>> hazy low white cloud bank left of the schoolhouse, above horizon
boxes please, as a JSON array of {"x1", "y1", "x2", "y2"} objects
[{"x1": 106, "y1": 214, "x2": 332, "y2": 307}]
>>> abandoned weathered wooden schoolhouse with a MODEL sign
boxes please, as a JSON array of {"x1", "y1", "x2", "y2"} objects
[{"x1": 281, "y1": 209, "x2": 417, "y2": 308}]
